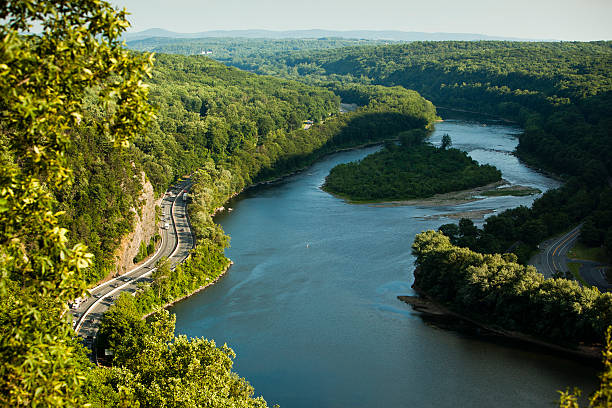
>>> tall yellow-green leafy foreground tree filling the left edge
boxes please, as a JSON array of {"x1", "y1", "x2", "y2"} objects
[{"x1": 0, "y1": 0, "x2": 153, "y2": 407}]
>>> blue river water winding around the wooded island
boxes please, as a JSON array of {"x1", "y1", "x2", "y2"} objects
[{"x1": 173, "y1": 120, "x2": 596, "y2": 408}]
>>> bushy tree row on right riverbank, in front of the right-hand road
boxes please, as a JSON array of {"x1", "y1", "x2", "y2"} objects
[{"x1": 412, "y1": 231, "x2": 612, "y2": 346}]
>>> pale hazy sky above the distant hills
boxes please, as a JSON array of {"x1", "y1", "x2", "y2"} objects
[{"x1": 110, "y1": 0, "x2": 612, "y2": 41}]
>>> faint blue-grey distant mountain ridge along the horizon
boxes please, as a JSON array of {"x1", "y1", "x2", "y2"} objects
[{"x1": 123, "y1": 28, "x2": 554, "y2": 41}]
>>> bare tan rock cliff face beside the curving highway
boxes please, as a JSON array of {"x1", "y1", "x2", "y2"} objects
[{"x1": 115, "y1": 173, "x2": 162, "y2": 275}]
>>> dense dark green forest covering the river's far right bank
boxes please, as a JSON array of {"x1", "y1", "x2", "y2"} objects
[{"x1": 221, "y1": 41, "x2": 612, "y2": 262}]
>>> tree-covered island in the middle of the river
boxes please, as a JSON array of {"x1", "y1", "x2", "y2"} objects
[{"x1": 323, "y1": 129, "x2": 501, "y2": 201}]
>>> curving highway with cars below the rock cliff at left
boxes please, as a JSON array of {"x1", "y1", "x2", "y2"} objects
[{"x1": 70, "y1": 179, "x2": 194, "y2": 349}]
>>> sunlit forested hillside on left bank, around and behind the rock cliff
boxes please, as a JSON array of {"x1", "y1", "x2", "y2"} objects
[{"x1": 58, "y1": 49, "x2": 436, "y2": 283}]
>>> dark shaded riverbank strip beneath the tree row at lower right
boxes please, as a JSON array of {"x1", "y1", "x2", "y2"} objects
[{"x1": 397, "y1": 286, "x2": 603, "y2": 364}]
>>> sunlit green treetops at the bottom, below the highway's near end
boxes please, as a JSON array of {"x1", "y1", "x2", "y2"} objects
[{"x1": 90, "y1": 308, "x2": 267, "y2": 408}]
